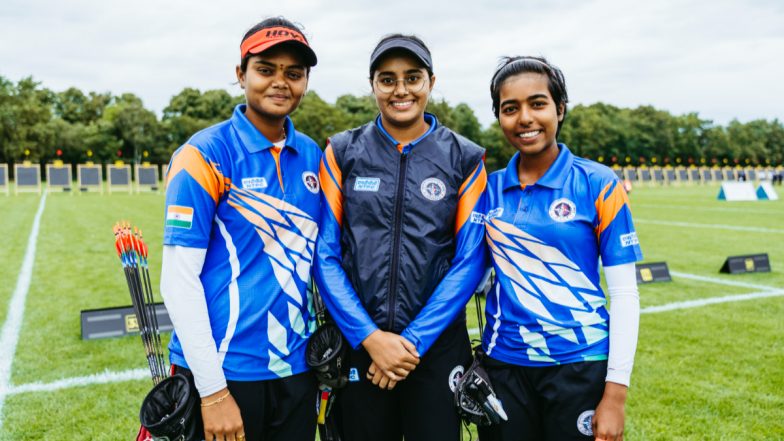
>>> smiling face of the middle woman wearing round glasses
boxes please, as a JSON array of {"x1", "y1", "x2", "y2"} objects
[{"x1": 372, "y1": 53, "x2": 435, "y2": 128}]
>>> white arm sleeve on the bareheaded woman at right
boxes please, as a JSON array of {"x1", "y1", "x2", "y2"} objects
[{"x1": 604, "y1": 262, "x2": 640, "y2": 386}]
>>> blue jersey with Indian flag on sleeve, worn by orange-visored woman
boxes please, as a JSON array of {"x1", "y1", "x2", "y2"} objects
[{"x1": 164, "y1": 105, "x2": 322, "y2": 381}]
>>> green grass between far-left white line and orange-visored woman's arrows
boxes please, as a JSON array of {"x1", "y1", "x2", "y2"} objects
[{"x1": 12, "y1": 194, "x2": 163, "y2": 384}]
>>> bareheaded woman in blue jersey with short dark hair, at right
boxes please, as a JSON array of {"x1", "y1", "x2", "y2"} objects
[{"x1": 479, "y1": 57, "x2": 642, "y2": 441}]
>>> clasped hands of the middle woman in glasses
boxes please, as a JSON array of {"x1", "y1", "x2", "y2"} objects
[{"x1": 362, "y1": 329, "x2": 419, "y2": 390}]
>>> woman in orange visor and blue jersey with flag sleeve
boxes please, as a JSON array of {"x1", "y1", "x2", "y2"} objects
[{"x1": 161, "y1": 17, "x2": 321, "y2": 441}]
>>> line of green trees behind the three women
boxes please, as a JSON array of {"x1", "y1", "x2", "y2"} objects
[{"x1": 0, "y1": 76, "x2": 784, "y2": 171}]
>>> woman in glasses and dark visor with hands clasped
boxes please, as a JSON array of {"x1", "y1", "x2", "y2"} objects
[{"x1": 315, "y1": 34, "x2": 486, "y2": 441}]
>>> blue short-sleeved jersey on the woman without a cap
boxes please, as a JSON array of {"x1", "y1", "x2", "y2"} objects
[{"x1": 483, "y1": 145, "x2": 642, "y2": 366}]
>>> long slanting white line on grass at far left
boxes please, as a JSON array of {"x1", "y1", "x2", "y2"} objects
[{"x1": 0, "y1": 191, "x2": 46, "y2": 429}]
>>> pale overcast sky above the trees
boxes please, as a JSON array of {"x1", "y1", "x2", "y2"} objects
[{"x1": 0, "y1": 0, "x2": 784, "y2": 125}]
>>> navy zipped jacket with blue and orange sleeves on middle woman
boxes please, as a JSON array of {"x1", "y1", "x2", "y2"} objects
[{"x1": 314, "y1": 114, "x2": 487, "y2": 355}]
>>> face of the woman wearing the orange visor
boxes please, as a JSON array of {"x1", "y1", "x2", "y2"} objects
[{"x1": 237, "y1": 47, "x2": 308, "y2": 123}]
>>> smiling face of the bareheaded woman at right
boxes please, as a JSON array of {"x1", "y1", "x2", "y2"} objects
[{"x1": 498, "y1": 73, "x2": 564, "y2": 157}]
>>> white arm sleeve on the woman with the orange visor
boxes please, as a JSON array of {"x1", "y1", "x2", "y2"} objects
[{"x1": 161, "y1": 245, "x2": 226, "y2": 397}]
